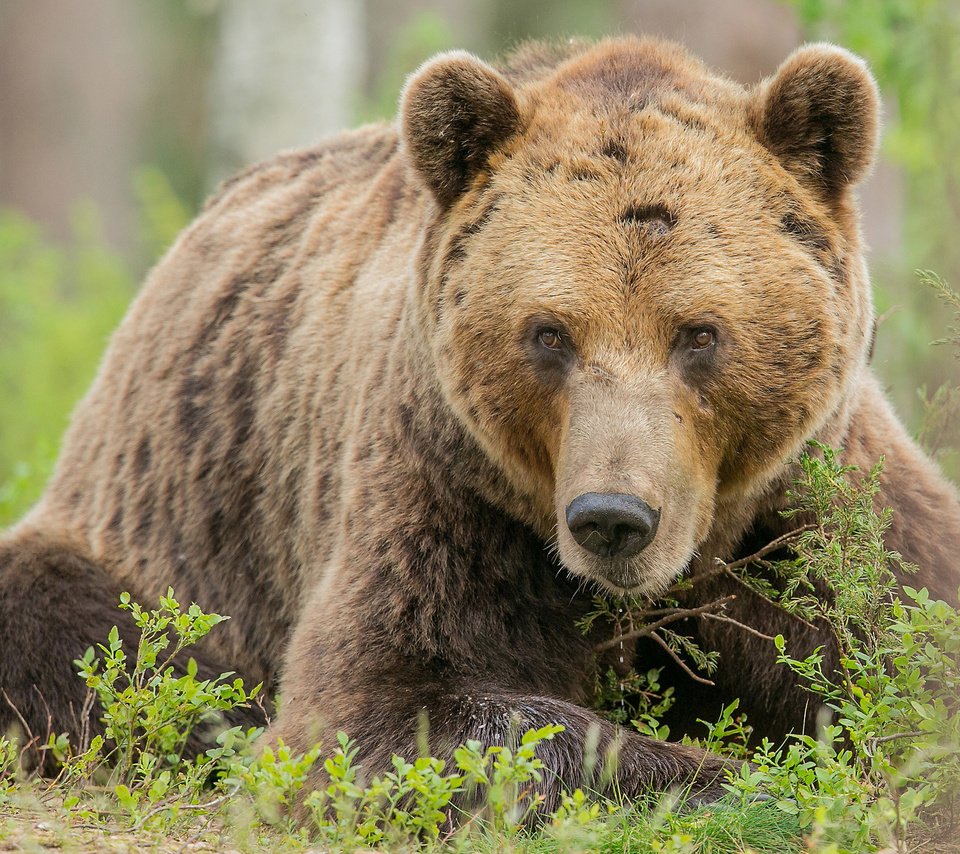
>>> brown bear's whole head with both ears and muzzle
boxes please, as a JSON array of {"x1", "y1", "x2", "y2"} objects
[{"x1": 401, "y1": 39, "x2": 878, "y2": 594}]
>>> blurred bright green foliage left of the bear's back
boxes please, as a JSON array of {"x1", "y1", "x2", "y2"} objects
[{"x1": 0, "y1": 169, "x2": 189, "y2": 528}]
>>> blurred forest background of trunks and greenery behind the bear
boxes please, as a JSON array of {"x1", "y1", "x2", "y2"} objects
[{"x1": 0, "y1": 0, "x2": 960, "y2": 527}]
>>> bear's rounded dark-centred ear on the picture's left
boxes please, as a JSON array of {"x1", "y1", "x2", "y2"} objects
[{"x1": 400, "y1": 51, "x2": 521, "y2": 207}]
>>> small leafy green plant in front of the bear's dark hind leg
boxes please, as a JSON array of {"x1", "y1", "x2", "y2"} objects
[{"x1": 6, "y1": 590, "x2": 260, "y2": 828}]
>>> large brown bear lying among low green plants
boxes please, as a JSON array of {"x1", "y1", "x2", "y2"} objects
[{"x1": 0, "y1": 38, "x2": 960, "y2": 808}]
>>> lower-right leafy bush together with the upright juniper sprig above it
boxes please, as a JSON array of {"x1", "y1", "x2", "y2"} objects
[{"x1": 733, "y1": 446, "x2": 960, "y2": 851}]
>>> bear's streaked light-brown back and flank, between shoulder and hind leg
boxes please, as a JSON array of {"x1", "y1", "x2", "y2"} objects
[{"x1": 20, "y1": 125, "x2": 424, "y2": 675}]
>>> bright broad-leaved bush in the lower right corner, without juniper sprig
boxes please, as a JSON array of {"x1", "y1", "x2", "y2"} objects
[{"x1": 733, "y1": 587, "x2": 960, "y2": 851}]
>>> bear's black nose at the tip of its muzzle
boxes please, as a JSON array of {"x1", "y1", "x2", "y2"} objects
[{"x1": 567, "y1": 492, "x2": 660, "y2": 557}]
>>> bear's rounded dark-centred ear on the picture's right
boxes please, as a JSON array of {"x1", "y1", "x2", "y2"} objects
[{"x1": 750, "y1": 44, "x2": 880, "y2": 199}]
